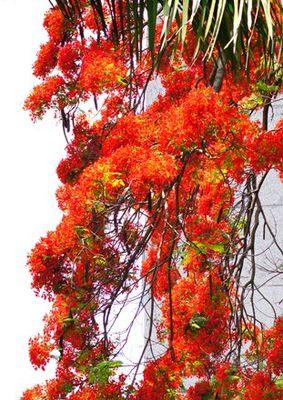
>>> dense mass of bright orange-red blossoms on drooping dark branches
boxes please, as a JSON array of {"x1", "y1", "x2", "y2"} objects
[{"x1": 22, "y1": 1, "x2": 283, "y2": 400}]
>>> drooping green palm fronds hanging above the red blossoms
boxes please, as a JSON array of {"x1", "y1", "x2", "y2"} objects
[{"x1": 52, "y1": 0, "x2": 283, "y2": 72}]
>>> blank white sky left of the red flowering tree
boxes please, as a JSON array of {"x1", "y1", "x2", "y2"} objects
[{"x1": 0, "y1": 0, "x2": 65, "y2": 400}]
